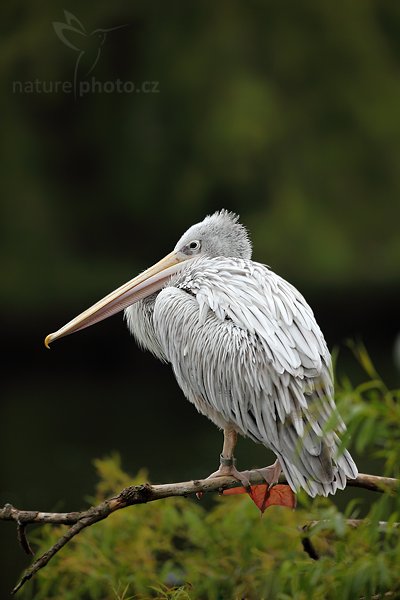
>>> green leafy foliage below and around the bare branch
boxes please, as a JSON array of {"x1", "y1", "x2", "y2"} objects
[{"x1": 23, "y1": 348, "x2": 400, "y2": 600}]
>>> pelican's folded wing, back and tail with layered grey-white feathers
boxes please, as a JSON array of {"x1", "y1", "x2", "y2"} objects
[{"x1": 154, "y1": 258, "x2": 356, "y2": 495}]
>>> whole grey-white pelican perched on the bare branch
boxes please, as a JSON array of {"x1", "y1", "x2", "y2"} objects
[{"x1": 45, "y1": 209, "x2": 357, "y2": 497}]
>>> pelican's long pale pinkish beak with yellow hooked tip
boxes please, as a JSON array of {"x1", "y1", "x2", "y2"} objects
[{"x1": 44, "y1": 252, "x2": 186, "y2": 348}]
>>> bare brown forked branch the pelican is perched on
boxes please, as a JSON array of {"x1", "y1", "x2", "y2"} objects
[{"x1": 0, "y1": 469, "x2": 400, "y2": 594}]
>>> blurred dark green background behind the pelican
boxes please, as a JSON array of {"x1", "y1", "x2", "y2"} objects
[{"x1": 0, "y1": 0, "x2": 400, "y2": 595}]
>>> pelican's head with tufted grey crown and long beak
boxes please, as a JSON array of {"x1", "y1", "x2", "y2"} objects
[{"x1": 45, "y1": 210, "x2": 251, "y2": 348}]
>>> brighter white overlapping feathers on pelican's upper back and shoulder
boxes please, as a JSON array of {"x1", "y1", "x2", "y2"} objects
[{"x1": 179, "y1": 258, "x2": 330, "y2": 377}]
